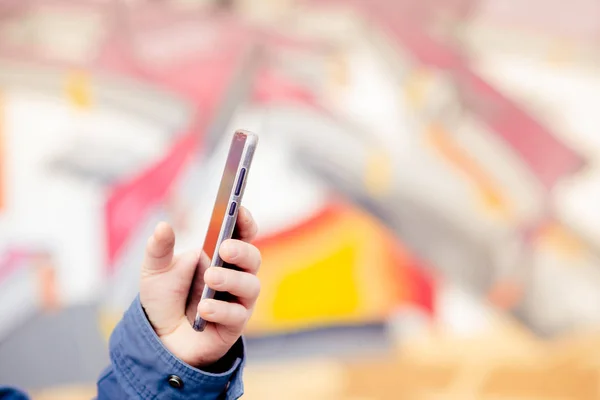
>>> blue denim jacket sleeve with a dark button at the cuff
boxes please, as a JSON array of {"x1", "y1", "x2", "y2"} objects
[{"x1": 0, "y1": 298, "x2": 245, "y2": 400}]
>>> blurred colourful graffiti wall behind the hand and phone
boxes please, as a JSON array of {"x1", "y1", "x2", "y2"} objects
[{"x1": 0, "y1": 0, "x2": 600, "y2": 400}]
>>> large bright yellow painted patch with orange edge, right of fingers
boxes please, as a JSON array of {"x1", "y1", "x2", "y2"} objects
[{"x1": 247, "y1": 210, "x2": 402, "y2": 335}]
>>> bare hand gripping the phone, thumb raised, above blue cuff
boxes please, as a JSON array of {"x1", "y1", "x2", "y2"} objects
[{"x1": 140, "y1": 207, "x2": 261, "y2": 368}]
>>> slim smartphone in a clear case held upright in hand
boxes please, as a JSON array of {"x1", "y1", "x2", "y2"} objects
[{"x1": 192, "y1": 130, "x2": 258, "y2": 332}]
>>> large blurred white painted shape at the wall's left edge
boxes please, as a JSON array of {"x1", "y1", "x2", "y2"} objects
[{"x1": 3, "y1": 90, "x2": 171, "y2": 303}]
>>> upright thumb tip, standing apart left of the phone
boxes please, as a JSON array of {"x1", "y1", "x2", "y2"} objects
[{"x1": 143, "y1": 222, "x2": 175, "y2": 273}]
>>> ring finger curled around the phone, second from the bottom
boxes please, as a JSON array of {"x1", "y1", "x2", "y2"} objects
[{"x1": 204, "y1": 267, "x2": 260, "y2": 308}]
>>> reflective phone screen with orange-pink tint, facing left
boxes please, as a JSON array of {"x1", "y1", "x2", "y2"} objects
[{"x1": 203, "y1": 133, "x2": 246, "y2": 260}]
